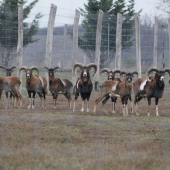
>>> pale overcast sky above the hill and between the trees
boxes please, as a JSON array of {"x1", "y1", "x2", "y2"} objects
[{"x1": 25, "y1": 0, "x2": 160, "y2": 26}]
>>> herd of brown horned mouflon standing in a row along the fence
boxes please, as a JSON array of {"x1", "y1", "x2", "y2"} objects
[{"x1": 0, "y1": 63, "x2": 170, "y2": 116}]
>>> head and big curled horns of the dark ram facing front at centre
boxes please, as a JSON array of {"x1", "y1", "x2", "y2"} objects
[{"x1": 73, "y1": 63, "x2": 97, "y2": 81}]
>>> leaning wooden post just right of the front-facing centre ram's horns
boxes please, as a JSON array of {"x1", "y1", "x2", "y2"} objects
[{"x1": 94, "y1": 10, "x2": 103, "y2": 91}]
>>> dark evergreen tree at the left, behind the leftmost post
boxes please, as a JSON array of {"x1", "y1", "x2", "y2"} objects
[{"x1": 0, "y1": 0, "x2": 42, "y2": 66}]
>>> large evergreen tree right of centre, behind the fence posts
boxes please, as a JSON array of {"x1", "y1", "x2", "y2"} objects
[{"x1": 79, "y1": 0, "x2": 141, "y2": 67}]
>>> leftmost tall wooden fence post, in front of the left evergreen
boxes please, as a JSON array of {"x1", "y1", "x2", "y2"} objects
[{"x1": 17, "y1": 4, "x2": 23, "y2": 93}]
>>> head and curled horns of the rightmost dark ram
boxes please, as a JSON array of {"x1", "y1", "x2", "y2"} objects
[{"x1": 146, "y1": 68, "x2": 170, "y2": 85}]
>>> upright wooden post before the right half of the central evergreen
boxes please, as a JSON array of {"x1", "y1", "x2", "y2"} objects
[{"x1": 115, "y1": 13, "x2": 122, "y2": 69}]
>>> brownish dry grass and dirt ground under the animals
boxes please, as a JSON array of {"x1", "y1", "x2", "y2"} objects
[{"x1": 0, "y1": 88, "x2": 170, "y2": 170}]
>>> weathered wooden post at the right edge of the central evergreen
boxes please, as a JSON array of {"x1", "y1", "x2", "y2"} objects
[{"x1": 135, "y1": 15, "x2": 141, "y2": 78}]
